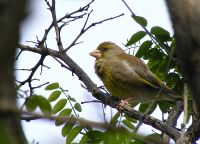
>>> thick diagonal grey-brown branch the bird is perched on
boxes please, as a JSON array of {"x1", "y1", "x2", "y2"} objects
[{"x1": 18, "y1": 45, "x2": 180, "y2": 140}]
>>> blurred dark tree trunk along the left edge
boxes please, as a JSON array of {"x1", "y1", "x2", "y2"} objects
[{"x1": 0, "y1": 0, "x2": 25, "y2": 144}]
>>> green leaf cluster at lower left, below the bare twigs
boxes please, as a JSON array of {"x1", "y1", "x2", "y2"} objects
[{"x1": 26, "y1": 82, "x2": 83, "y2": 143}]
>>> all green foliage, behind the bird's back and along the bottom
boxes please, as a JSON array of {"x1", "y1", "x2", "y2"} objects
[{"x1": 23, "y1": 13, "x2": 186, "y2": 144}]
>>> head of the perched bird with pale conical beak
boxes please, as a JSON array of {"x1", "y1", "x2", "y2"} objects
[{"x1": 90, "y1": 42, "x2": 124, "y2": 59}]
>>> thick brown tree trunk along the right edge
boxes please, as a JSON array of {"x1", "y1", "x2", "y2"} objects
[{"x1": 166, "y1": 0, "x2": 200, "y2": 143}]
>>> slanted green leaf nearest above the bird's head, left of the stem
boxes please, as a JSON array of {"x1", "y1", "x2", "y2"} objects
[{"x1": 126, "y1": 31, "x2": 146, "y2": 46}]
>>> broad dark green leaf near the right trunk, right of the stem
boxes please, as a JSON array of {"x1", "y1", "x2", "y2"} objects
[{"x1": 150, "y1": 26, "x2": 171, "y2": 42}]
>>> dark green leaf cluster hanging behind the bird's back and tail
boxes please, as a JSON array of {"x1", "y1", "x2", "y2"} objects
[{"x1": 126, "y1": 16, "x2": 187, "y2": 112}]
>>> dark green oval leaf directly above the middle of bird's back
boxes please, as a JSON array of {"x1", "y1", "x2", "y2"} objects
[{"x1": 135, "y1": 40, "x2": 153, "y2": 58}]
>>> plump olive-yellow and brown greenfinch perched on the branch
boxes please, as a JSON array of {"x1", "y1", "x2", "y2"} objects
[{"x1": 90, "y1": 42, "x2": 177, "y2": 102}]
